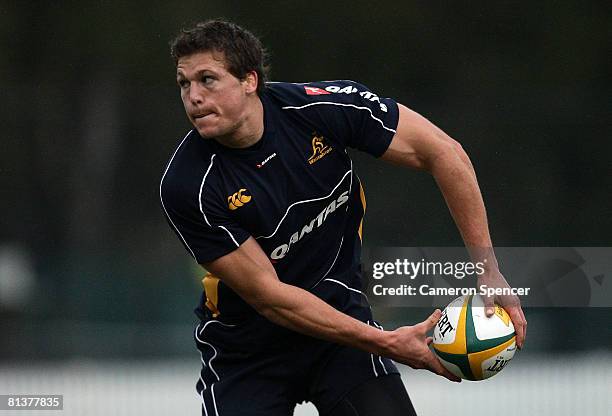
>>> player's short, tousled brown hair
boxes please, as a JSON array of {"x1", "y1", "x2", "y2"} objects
[{"x1": 170, "y1": 19, "x2": 269, "y2": 93}]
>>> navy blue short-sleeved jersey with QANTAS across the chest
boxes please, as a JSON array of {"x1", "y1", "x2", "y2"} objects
[{"x1": 160, "y1": 81, "x2": 398, "y2": 344}]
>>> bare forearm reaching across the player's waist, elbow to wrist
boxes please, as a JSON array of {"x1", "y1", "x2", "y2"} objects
[{"x1": 253, "y1": 281, "x2": 393, "y2": 355}]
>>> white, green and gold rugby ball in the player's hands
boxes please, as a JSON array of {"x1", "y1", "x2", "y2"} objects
[{"x1": 433, "y1": 295, "x2": 516, "y2": 381}]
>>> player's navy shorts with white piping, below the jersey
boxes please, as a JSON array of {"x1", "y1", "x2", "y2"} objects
[{"x1": 194, "y1": 319, "x2": 399, "y2": 416}]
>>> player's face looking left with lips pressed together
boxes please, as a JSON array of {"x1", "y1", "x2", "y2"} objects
[{"x1": 176, "y1": 51, "x2": 257, "y2": 138}]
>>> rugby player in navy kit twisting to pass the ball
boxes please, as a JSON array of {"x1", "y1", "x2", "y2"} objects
[{"x1": 160, "y1": 20, "x2": 526, "y2": 416}]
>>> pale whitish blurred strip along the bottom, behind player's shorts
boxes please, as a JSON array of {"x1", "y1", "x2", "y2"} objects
[{"x1": 0, "y1": 349, "x2": 612, "y2": 416}]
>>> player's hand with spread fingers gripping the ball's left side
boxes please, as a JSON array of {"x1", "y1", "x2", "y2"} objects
[{"x1": 389, "y1": 309, "x2": 461, "y2": 382}]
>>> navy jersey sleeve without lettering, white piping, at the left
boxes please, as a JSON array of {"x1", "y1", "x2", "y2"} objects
[{"x1": 160, "y1": 172, "x2": 250, "y2": 264}]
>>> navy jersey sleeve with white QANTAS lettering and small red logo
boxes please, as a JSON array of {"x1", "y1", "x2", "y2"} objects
[{"x1": 288, "y1": 81, "x2": 399, "y2": 157}]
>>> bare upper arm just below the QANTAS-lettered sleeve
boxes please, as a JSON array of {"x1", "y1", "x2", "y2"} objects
[{"x1": 381, "y1": 104, "x2": 458, "y2": 170}]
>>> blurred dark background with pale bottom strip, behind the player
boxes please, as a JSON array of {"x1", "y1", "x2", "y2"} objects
[{"x1": 0, "y1": 0, "x2": 612, "y2": 415}]
